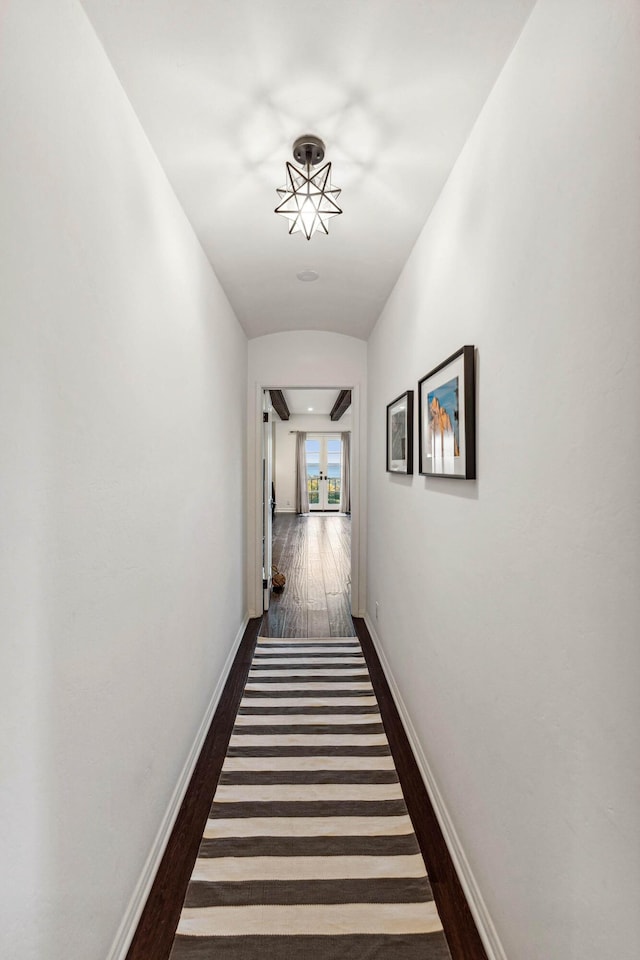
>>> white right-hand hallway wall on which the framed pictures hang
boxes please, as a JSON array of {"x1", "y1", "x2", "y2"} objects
[{"x1": 368, "y1": 0, "x2": 640, "y2": 960}]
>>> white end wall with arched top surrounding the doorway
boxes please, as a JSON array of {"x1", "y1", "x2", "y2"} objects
[{"x1": 247, "y1": 330, "x2": 367, "y2": 615}]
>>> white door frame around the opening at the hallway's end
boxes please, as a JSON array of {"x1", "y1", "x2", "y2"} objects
[{"x1": 247, "y1": 382, "x2": 366, "y2": 617}]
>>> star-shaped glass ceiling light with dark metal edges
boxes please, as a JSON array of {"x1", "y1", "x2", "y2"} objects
[{"x1": 275, "y1": 134, "x2": 342, "y2": 240}]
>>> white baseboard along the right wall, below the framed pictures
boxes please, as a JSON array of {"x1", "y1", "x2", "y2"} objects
[{"x1": 364, "y1": 613, "x2": 507, "y2": 960}]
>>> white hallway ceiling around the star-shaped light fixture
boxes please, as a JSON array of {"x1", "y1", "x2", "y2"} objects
[{"x1": 83, "y1": 0, "x2": 535, "y2": 338}]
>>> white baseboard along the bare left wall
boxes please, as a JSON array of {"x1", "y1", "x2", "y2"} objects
[{"x1": 107, "y1": 616, "x2": 249, "y2": 960}]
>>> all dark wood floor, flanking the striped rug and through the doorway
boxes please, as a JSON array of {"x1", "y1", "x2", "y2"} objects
[{"x1": 127, "y1": 514, "x2": 487, "y2": 960}]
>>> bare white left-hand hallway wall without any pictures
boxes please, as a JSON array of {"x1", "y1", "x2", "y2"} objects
[{"x1": 0, "y1": 0, "x2": 247, "y2": 960}]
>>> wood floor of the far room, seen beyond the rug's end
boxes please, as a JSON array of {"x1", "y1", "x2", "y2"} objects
[{"x1": 262, "y1": 513, "x2": 355, "y2": 637}]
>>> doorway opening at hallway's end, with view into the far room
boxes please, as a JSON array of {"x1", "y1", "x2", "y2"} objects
[{"x1": 262, "y1": 388, "x2": 355, "y2": 637}]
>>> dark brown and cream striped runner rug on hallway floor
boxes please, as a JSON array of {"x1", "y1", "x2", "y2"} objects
[{"x1": 171, "y1": 637, "x2": 450, "y2": 960}]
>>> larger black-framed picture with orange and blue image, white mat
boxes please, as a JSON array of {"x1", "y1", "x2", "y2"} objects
[{"x1": 418, "y1": 346, "x2": 476, "y2": 480}]
